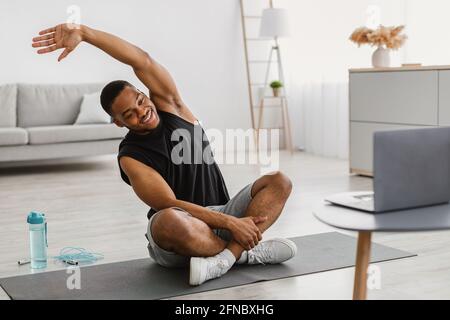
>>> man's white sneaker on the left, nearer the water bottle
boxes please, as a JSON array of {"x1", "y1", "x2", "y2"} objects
[{"x1": 189, "y1": 256, "x2": 231, "y2": 286}]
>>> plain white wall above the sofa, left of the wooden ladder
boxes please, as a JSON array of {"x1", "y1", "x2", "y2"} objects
[{"x1": 0, "y1": 0, "x2": 250, "y2": 129}]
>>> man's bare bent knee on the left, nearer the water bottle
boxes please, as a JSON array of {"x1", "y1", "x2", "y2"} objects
[{"x1": 151, "y1": 208, "x2": 193, "y2": 251}]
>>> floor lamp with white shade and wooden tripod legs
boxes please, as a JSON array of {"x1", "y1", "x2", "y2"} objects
[{"x1": 257, "y1": 7, "x2": 293, "y2": 152}]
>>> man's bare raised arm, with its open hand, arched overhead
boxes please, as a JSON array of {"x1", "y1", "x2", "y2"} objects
[{"x1": 32, "y1": 24, "x2": 184, "y2": 106}]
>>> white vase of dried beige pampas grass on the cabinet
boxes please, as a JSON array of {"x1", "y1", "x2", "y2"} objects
[{"x1": 350, "y1": 25, "x2": 407, "y2": 68}]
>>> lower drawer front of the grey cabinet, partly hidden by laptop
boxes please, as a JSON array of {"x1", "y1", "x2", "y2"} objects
[{"x1": 350, "y1": 122, "x2": 429, "y2": 174}]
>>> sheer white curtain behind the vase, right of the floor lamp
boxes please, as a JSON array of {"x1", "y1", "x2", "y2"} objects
[{"x1": 275, "y1": 0, "x2": 407, "y2": 158}]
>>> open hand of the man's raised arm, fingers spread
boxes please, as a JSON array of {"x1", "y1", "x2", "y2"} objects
[{"x1": 32, "y1": 23, "x2": 83, "y2": 61}]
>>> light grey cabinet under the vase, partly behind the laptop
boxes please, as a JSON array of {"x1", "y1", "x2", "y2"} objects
[{"x1": 349, "y1": 66, "x2": 450, "y2": 175}]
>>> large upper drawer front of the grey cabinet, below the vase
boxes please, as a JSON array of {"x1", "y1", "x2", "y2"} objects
[{"x1": 350, "y1": 71, "x2": 438, "y2": 125}]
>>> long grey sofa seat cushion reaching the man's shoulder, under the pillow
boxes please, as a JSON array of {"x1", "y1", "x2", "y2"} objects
[{"x1": 26, "y1": 124, "x2": 128, "y2": 144}]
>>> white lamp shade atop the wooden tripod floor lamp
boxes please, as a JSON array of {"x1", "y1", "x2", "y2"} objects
[{"x1": 259, "y1": 8, "x2": 290, "y2": 38}]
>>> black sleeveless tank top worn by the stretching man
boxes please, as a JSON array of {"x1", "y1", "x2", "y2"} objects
[{"x1": 117, "y1": 111, "x2": 230, "y2": 219}]
